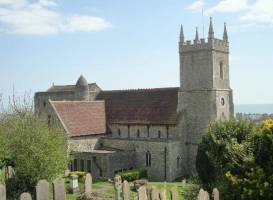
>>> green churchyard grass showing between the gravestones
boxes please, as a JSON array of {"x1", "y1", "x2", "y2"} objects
[{"x1": 66, "y1": 180, "x2": 199, "y2": 200}]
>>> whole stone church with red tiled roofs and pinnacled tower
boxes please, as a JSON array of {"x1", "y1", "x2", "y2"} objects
[{"x1": 35, "y1": 18, "x2": 233, "y2": 181}]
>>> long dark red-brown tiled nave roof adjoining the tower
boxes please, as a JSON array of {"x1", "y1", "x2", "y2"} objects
[{"x1": 96, "y1": 87, "x2": 179, "y2": 124}]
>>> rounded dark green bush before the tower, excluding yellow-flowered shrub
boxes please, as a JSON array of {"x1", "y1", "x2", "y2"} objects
[{"x1": 196, "y1": 120, "x2": 256, "y2": 189}]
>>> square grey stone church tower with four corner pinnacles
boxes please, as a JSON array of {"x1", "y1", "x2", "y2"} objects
[{"x1": 178, "y1": 18, "x2": 233, "y2": 175}]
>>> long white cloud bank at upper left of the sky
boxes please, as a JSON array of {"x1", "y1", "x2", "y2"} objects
[{"x1": 0, "y1": 0, "x2": 110, "y2": 35}]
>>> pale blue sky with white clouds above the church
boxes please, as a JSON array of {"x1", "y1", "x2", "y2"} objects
[{"x1": 0, "y1": 0, "x2": 273, "y2": 104}]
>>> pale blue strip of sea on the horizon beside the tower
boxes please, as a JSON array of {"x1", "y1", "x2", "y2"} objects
[{"x1": 234, "y1": 104, "x2": 273, "y2": 114}]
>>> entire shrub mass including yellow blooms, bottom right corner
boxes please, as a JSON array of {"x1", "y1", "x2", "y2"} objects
[{"x1": 197, "y1": 120, "x2": 273, "y2": 200}]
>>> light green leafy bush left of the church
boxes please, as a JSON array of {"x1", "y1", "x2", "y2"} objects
[{"x1": 0, "y1": 97, "x2": 68, "y2": 198}]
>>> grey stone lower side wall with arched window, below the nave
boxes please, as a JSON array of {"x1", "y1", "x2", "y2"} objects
[{"x1": 101, "y1": 137, "x2": 182, "y2": 181}]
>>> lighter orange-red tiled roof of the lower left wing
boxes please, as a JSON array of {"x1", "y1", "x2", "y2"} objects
[{"x1": 50, "y1": 101, "x2": 106, "y2": 137}]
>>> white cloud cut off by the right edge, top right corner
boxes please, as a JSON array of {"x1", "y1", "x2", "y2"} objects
[{"x1": 240, "y1": 0, "x2": 273, "y2": 24}]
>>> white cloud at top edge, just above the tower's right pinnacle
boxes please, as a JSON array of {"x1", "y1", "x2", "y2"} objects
[{"x1": 205, "y1": 0, "x2": 248, "y2": 14}]
